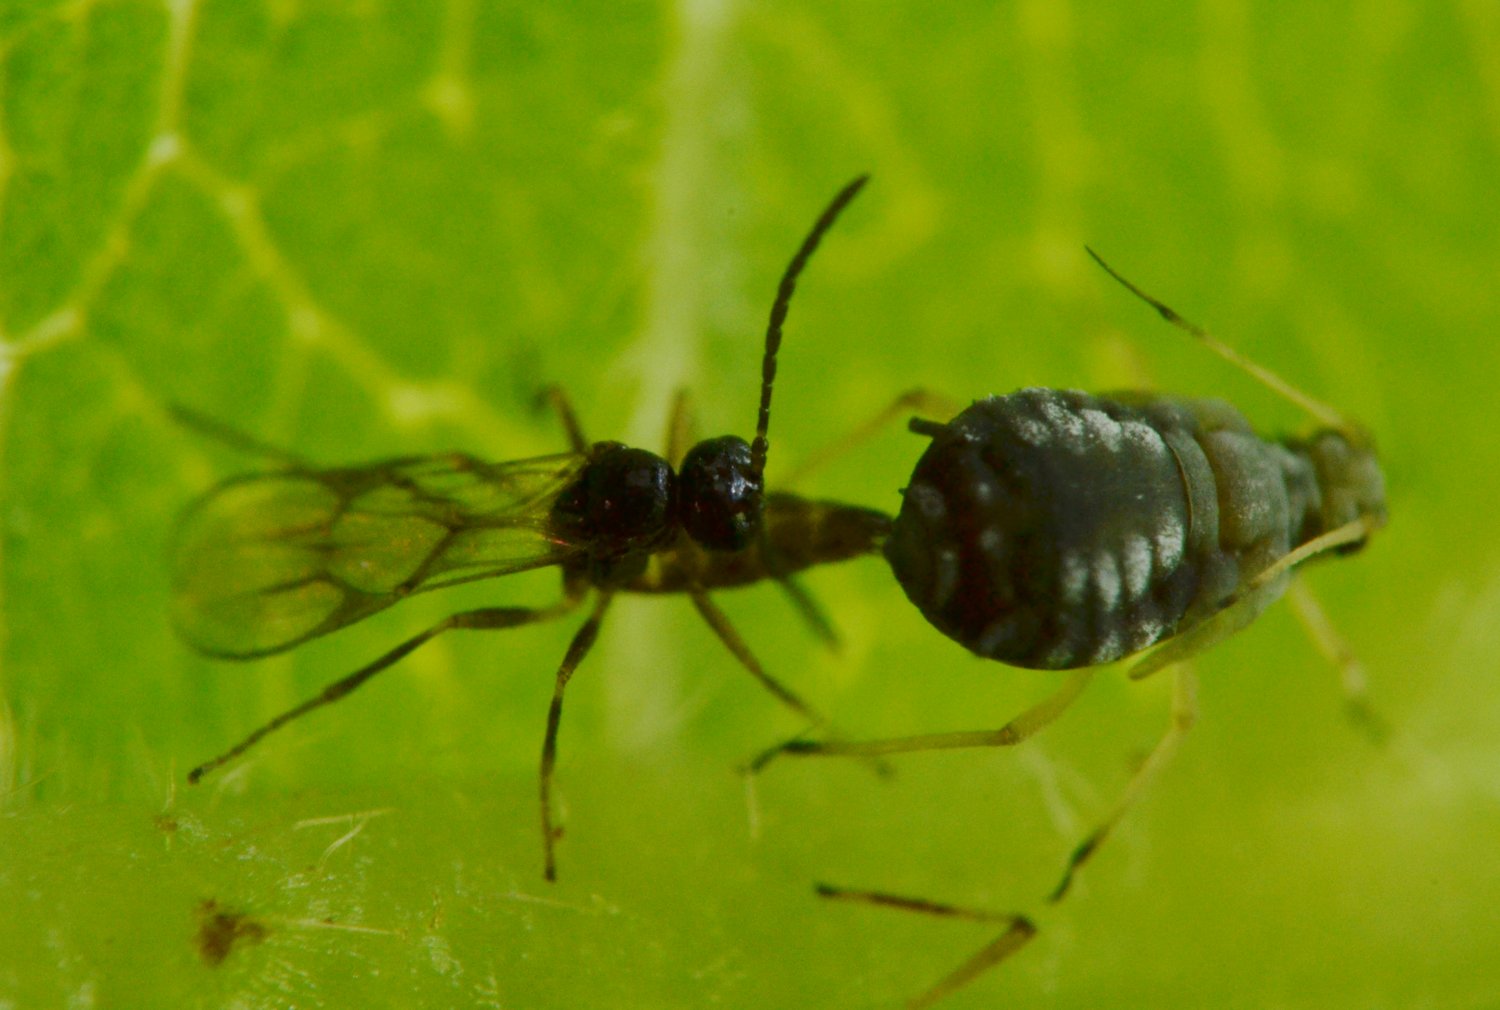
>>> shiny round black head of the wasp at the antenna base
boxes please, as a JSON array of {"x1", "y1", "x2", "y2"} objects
[{"x1": 678, "y1": 435, "x2": 765, "y2": 551}]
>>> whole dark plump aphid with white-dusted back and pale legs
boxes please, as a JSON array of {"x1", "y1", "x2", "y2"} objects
[{"x1": 756, "y1": 249, "x2": 1386, "y2": 1008}]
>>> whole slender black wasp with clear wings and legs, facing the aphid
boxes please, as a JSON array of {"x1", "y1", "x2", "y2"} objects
[{"x1": 173, "y1": 176, "x2": 891, "y2": 879}]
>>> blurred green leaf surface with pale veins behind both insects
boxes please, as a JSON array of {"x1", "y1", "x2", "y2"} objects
[{"x1": 0, "y1": 0, "x2": 1500, "y2": 1010}]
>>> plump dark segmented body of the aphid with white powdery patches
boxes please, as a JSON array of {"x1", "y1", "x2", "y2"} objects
[{"x1": 885, "y1": 389, "x2": 1319, "y2": 669}]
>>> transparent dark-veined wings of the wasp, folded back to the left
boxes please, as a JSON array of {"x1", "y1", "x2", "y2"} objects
[{"x1": 171, "y1": 453, "x2": 587, "y2": 659}]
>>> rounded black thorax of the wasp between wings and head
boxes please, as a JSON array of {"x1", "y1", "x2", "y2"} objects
[{"x1": 552, "y1": 441, "x2": 677, "y2": 554}]
